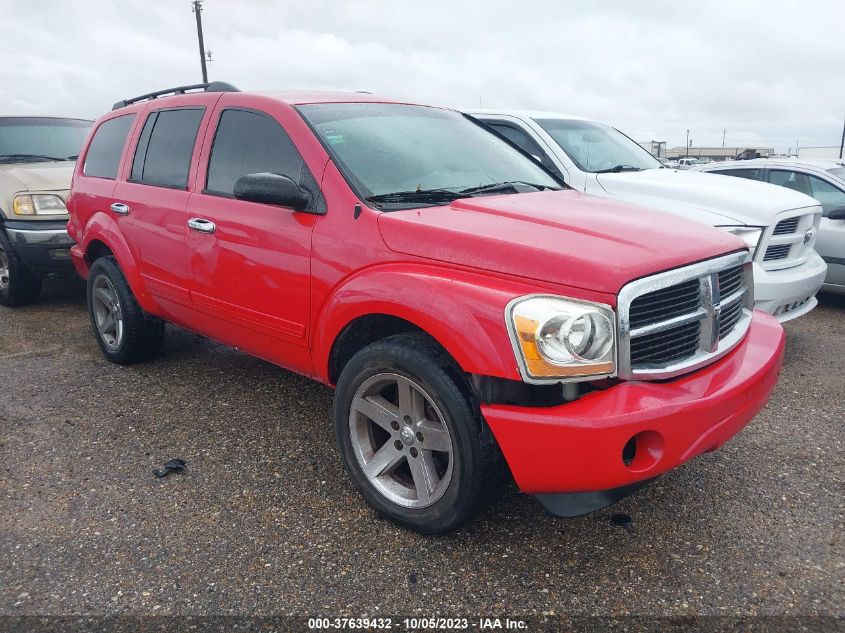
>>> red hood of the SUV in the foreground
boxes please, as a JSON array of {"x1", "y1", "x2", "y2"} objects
[{"x1": 379, "y1": 191, "x2": 745, "y2": 294}]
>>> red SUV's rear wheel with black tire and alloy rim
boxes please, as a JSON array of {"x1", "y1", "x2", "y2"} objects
[{"x1": 87, "y1": 257, "x2": 164, "y2": 365}]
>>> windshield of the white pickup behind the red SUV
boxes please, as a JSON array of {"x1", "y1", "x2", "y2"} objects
[{"x1": 535, "y1": 119, "x2": 660, "y2": 173}]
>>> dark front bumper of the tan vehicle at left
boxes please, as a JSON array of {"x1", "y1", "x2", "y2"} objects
[{"x1": 4, "y1": 220, "x2": 74, "y2": 273}]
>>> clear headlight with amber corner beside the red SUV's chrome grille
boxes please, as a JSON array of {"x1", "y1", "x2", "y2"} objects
[{"x1": 505, "y1": 295, "x2": 616, "y2": 382}]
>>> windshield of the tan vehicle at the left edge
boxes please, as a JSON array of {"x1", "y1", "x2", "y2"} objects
[{"x1": 0, "y1": 117, "x2": 91, "y2": 163}]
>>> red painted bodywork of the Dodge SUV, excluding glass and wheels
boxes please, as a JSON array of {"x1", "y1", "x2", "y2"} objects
[{"x1": 68, "y1": 93, "x2": 783, "y2": 492}]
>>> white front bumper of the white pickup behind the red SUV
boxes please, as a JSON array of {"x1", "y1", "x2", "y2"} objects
[{"x1": 754, "y1": 251, "x2": 827, "y2": 323}]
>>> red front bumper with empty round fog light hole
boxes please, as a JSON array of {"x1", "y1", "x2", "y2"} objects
[{"x1": 481, "y1": 311, "x2": 784, "y2": 516}]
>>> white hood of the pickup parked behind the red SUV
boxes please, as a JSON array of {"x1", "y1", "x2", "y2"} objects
[{"x1": 597, "y1": 169, "x2": 818, "y2": 226}]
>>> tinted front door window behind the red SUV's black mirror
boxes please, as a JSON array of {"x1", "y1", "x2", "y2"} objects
[{"x1": 205, "y1": 110, "x2": 308, "y2": 196}]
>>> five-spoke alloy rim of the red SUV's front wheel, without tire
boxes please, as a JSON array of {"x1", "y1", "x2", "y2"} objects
[{"x1": 349, "y1": 373, "x2": 455, "y2": 508}]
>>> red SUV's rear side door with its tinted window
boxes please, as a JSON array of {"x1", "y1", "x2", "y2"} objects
[{"x1": 111, "y1": 95, "x2": 214, "y2": 314}]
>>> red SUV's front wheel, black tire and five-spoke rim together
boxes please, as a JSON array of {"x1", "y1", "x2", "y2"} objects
[{"x1": 332, "y1": 334, "x2": 499, "y2": 534}]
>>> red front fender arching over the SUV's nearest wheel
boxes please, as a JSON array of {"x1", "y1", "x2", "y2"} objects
[{"x1": 311, "y1": 262, "x2": 552, "y2": 384}]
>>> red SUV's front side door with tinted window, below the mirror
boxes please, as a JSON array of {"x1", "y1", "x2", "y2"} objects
[{"x1": 187, "y1": 106, "x2": 322, "y2": 372}]
